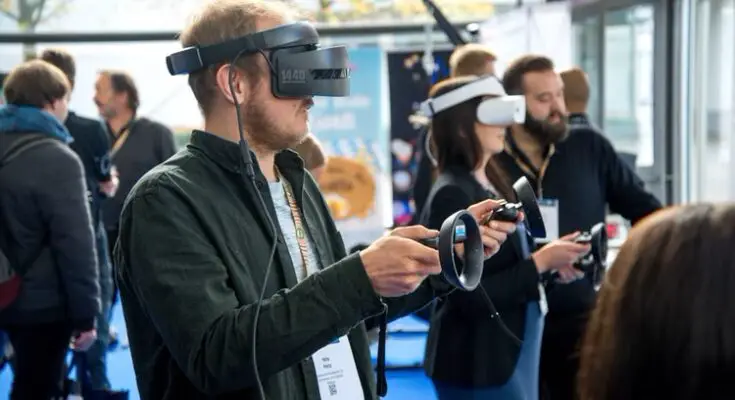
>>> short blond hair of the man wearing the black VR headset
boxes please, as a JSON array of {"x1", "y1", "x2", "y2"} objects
[{"x1": 180, "y1": 0, "x2": 296, "y2": 116}]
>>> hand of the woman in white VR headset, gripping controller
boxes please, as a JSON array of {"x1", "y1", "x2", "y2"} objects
[{"x1": 531, "y1": 232, "x2": 590, "y2": 283}]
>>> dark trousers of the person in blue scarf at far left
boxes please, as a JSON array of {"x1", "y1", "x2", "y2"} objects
[{"x1": 5, "y1": 322, "x2": 72, "y2": 400}]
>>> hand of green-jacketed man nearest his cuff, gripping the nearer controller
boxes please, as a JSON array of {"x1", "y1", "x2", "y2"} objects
[{"x1": 360, "y1": 225, "x2": 442, "y2": 297}]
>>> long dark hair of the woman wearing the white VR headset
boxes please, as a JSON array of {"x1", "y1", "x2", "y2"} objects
[{"x1": 429, "y1": 76, "x2": 515, "y2": 200}]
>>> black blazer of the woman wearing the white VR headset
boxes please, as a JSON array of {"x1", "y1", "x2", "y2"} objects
[{"x1": 422, "y1": 168, "x2": 540, "y2": 387}]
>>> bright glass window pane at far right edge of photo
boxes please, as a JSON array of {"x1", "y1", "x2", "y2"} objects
[{"x1": 688, "y1": 0, "x2": 735, "y2": 201}]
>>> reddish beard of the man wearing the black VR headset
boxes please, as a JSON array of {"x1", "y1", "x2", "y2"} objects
[{"x1": 240, "y1": 100, "x2": 308, "y2": 152}]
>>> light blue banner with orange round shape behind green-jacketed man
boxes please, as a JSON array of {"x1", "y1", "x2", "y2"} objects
[{"x1": 309, "y1": 47, "x2": 392, "y2": 248}]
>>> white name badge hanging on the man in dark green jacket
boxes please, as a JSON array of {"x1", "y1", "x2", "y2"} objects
[{"x1": 312, "y1": 336, "x2": 365, "y2": 400}]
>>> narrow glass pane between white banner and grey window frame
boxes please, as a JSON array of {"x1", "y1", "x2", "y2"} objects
[{"x1": 573, "y1": 17, "x2": 602, "y2": 124}]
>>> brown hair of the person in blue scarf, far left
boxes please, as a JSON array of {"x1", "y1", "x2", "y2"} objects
[{"x1": 3, "y1": 60, "x2": 71, "y2": 108}]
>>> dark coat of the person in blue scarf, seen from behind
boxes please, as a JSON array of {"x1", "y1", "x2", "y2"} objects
[{"x1": 0, "y1": 133, "x2": 100, "y2": 330}]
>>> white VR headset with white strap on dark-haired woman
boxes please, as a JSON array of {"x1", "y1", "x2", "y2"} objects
[{"x1": 418, "y1": 75, "x2": 526, "y2": 126}]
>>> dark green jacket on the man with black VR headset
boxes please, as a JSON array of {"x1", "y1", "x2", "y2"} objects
[{"x1": 115, "y1": 131, "x2": 442, "y2": 400}]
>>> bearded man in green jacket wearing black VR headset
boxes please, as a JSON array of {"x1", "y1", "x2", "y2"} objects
[{"x1": 115, "y1": 0, "x2": 515, "y2": 400}]
